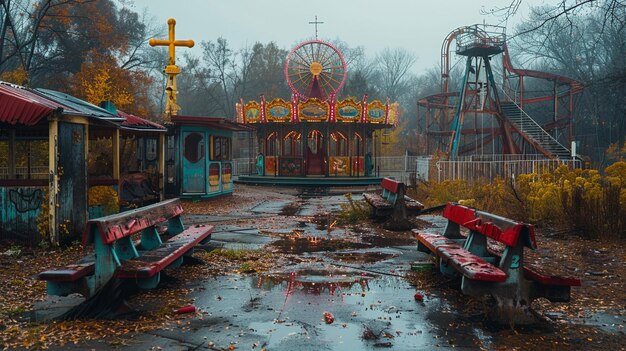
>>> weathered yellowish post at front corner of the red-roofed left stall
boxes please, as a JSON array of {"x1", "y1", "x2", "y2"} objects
[{"x1": 48, "y1": 117, "x2": 59, "y2": 245}]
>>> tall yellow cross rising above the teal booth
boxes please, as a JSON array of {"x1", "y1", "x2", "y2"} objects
[{"x1": 149, "y1": 18, "x2": 195, "y2": 122}]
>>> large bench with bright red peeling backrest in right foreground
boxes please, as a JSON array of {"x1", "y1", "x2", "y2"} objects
[{"x1": 413, "y1": 203, "x2": 580, "y2": 314}]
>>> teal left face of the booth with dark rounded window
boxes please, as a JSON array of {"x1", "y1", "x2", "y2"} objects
[{"x1": 182, "y1": 132, "x2": 207, "y2": 194}]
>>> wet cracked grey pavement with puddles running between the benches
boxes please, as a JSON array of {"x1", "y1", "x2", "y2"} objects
[{"x1": 40, "y1": 188, "x2": 615, "y2": 351}]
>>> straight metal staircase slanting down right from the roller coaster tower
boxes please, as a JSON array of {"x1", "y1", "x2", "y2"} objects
[{"x1": 500, "y1": 101, "x2": 571, "y2": 159}]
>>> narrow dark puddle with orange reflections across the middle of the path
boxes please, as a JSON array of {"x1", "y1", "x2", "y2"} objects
[{"x1": 268, "y1": 236, "x2": 370, "y2": 254}]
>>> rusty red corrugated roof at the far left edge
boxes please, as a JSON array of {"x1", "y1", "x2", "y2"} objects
[{"x1": 0, "y1": 82, "x2": 63, "y2": 126}]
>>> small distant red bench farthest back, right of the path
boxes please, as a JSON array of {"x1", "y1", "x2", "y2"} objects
[{"x1": 363, "y1": 178, "x2": 424, "y2": 218}]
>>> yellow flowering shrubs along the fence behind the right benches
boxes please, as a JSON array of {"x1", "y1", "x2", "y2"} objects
[{"x1": 411, "y1": 161, "x2": 626, "y2": 238}]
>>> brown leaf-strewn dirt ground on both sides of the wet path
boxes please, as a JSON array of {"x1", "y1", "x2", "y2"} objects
[{"x1": 0, "y1": 185, "x2": 626, "y2": 350}]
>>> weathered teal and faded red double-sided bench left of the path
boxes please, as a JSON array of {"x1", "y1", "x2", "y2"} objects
[{"x1": 39, "y1": 199, "x2": 213, "y2": 296}]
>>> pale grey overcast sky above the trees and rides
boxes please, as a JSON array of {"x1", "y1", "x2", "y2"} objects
[{"x1": 128, "y1": 0, "x2": 554, "y2": 73}]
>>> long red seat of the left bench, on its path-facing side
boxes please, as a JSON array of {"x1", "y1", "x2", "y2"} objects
[{"x1": 115, "y1": 225, "x2": 213, "y2": 278}]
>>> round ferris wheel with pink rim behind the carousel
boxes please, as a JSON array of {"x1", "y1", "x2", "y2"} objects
[{"x1": 285, "y1": 40, "x2": 346, "y2": 100}]
